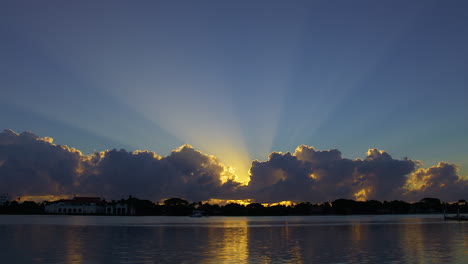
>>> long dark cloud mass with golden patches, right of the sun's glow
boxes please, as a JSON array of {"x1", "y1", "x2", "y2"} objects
[{"x1": 244, "y1": 145, "x2": 462, "y2": 202}]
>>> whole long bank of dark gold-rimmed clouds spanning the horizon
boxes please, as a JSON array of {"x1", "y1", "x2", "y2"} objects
[{"x1": 0, "y1": 130, "x2": 468, "y2": 203}]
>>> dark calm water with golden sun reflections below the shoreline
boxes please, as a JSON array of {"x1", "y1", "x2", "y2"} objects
[{"x1": 0, "y1": 215, "x2": 468, "y2": 264}]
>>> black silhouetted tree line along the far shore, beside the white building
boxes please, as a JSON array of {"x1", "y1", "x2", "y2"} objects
[{"x1": 0, "y1": 197, "x2": 468, "y2": 216}]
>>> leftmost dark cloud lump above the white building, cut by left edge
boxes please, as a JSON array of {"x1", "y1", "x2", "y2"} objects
[{"x1": 0, "y1": 130, "x2": 86, "y2": 195}]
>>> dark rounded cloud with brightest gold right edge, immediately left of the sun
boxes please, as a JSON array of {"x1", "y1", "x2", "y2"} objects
[{"x1": 82, "y1": 145, "x2": 238, "y2": 201}]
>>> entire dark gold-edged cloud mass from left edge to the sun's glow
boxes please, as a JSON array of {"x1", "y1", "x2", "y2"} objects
[{"x1": 0, "y1": 130, "x2": 239, "y2": 201}]
